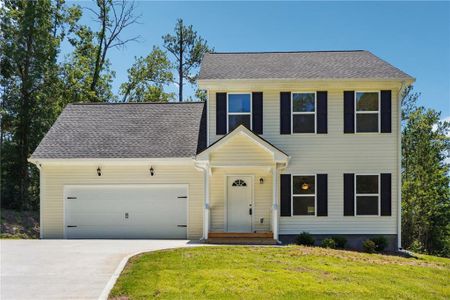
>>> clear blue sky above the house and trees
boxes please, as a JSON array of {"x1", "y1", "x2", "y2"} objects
[{"x1": 67, "y1": 1, "x2": 450, "y2": 118}]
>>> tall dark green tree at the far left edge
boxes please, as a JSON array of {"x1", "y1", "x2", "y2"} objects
[{"x1": 0, "y1": 0, "x2": 66, "y2": 209}]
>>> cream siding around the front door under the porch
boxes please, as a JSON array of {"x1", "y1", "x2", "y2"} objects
[{"x1": 210, "y1": 168, "x2": 272, "y2": 232}]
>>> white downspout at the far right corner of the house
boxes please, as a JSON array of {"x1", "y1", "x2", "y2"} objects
[{"x1": 397, "y1": 81, "x2": 406, "y2": 250}]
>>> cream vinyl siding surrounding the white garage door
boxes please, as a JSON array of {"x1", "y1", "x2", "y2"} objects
[{"x1": 41, "y1": 164, "x2": 204, "y2": 239}]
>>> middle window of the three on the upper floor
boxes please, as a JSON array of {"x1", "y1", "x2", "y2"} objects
[{"x1": 292, "y1": 93, "x2": 316, "y2": 133}]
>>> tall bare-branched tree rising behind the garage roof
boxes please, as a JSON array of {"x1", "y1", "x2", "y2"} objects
[{"x1": 84, "y1": 0, "x2": 139, "y2": 101}]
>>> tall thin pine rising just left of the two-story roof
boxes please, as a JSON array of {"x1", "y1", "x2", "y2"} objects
[{"x1": 162, "y1": 19, "x2": 212, "y2": 102}]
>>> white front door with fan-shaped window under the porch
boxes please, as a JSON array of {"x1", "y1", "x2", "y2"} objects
[{"x1": 227, "y1": 176, "x2": 253, "y2": 232}]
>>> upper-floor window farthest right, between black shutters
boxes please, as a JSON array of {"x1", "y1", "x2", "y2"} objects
[{"x1": 355, "y1": 92, "x2": 380, "y2": 132}]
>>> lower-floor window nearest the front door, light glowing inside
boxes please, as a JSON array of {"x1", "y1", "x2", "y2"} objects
[{"x1": 292, "y1": 175, "x2": 316, "y2": 216}]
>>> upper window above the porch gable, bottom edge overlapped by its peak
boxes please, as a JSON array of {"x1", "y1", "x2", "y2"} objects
[{"x1": 227, "y1": 94, "x2": 252, "y2": 132}]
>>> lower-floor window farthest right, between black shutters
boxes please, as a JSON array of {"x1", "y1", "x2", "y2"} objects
[{"x1": 355, "y1": 175, "x2": 380, "y2": 216}]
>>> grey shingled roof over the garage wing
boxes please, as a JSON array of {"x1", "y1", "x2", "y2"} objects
[{"x1": 31, "y1": 102, "x2": 206, "y2": 159}]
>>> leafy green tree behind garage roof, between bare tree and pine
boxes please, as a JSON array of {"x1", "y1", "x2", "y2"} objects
[{"x1": 120, "y1": 47, "x2": 173, "y2": 102}]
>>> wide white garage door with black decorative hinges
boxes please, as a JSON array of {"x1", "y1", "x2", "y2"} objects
[{"x1": 64, "y1": 185, "x2": 187, "y2": 239}]
